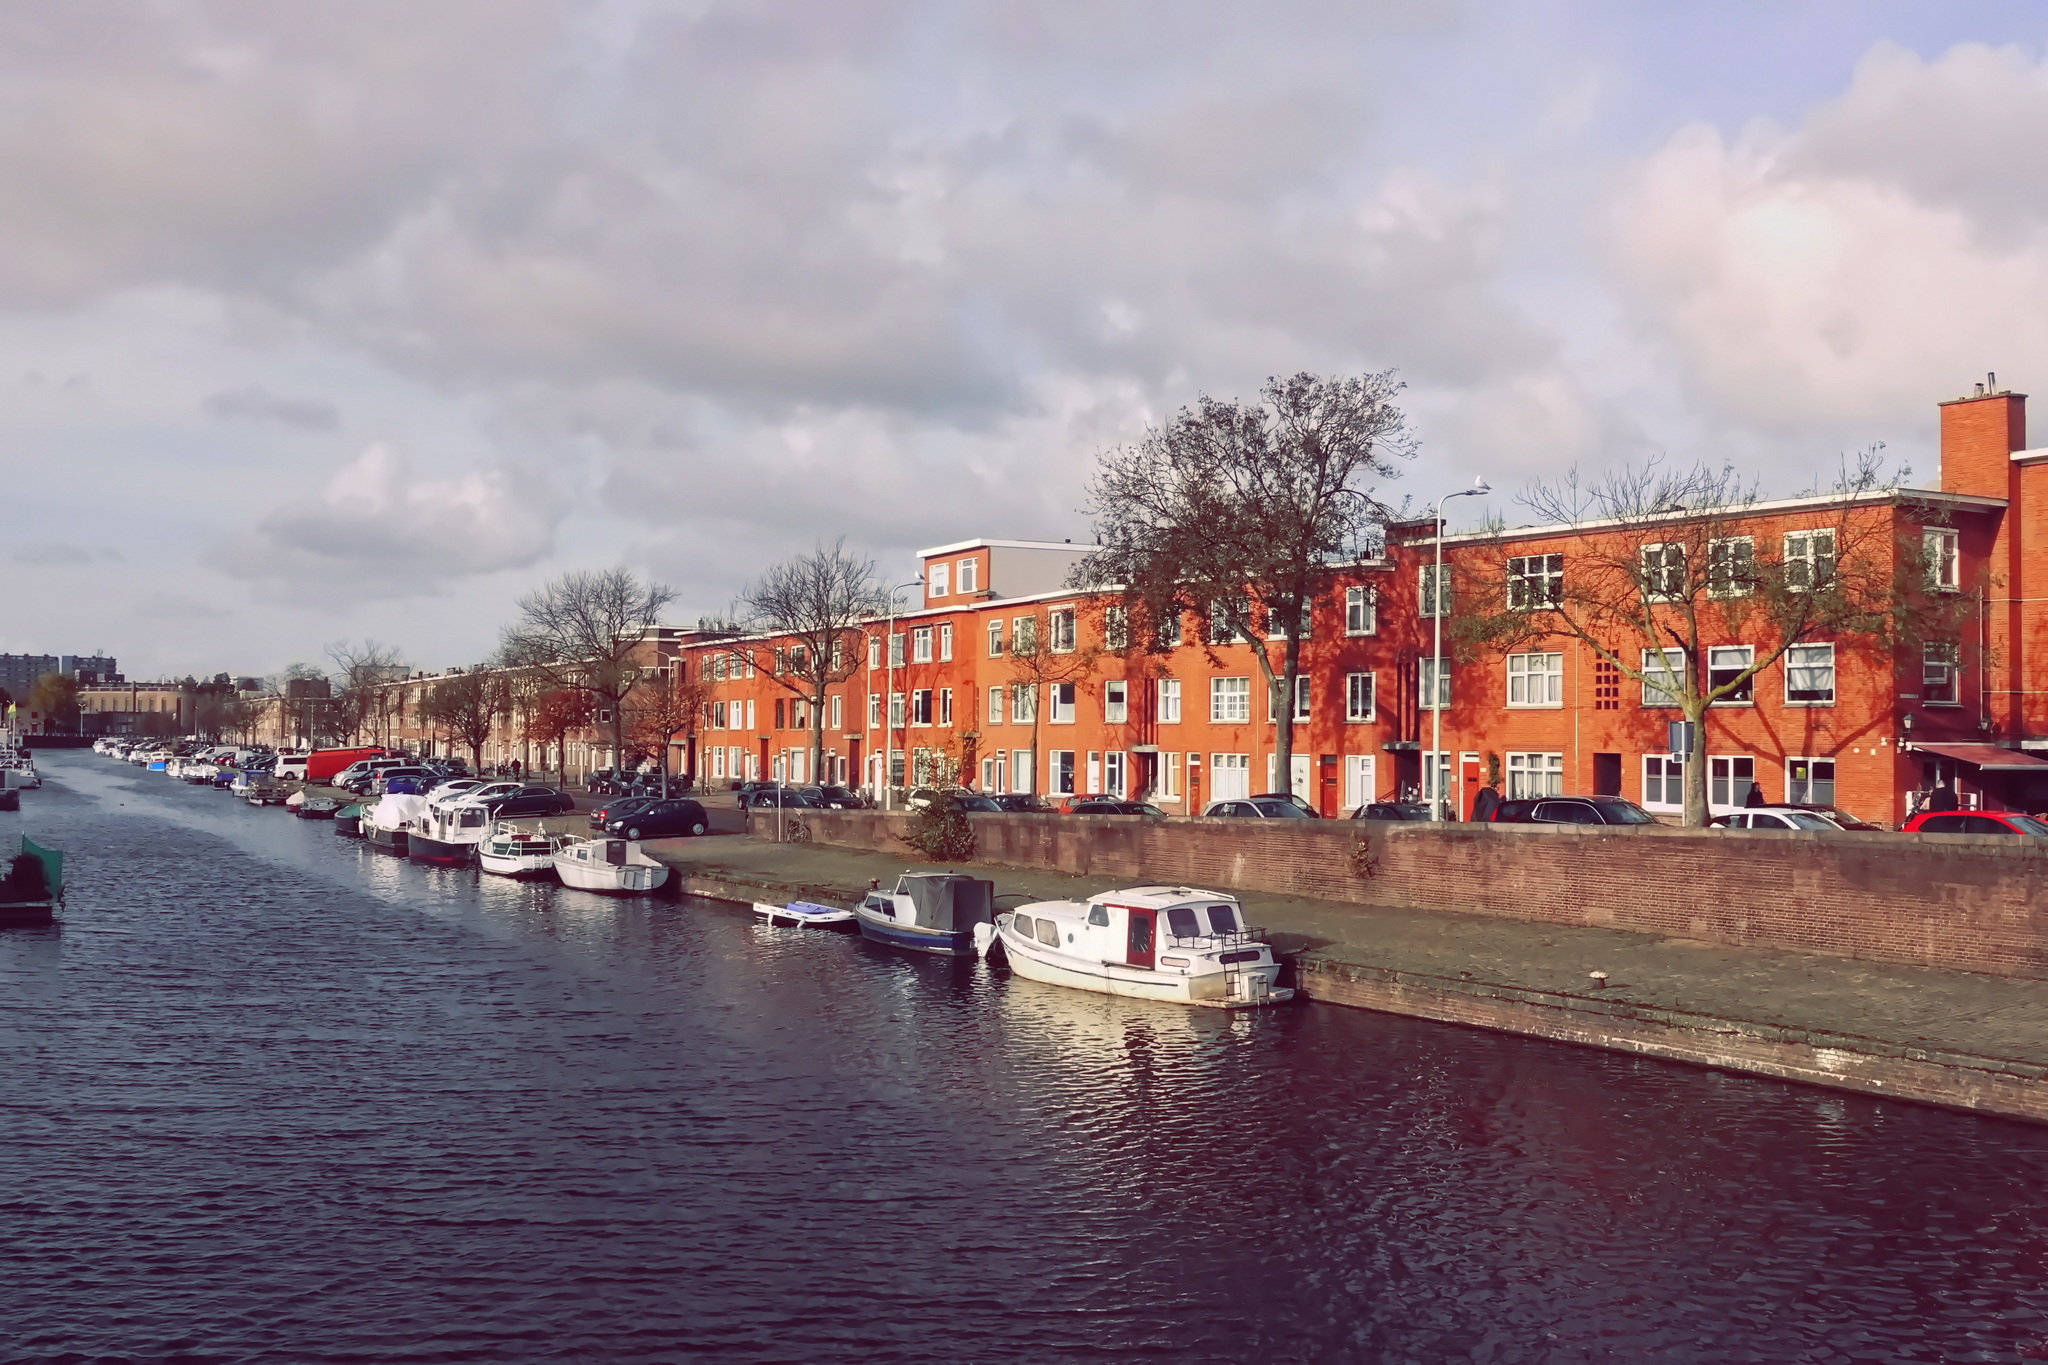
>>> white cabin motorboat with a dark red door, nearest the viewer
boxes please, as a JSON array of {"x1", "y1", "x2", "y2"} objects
[{"x1": 975, "y1": 886, "x2": 1294, "y2": 1009}]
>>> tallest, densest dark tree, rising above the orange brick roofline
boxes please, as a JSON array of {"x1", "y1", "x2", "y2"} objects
[{"x1": 1071, "y1": 370, "x2": 1413, "y2": 802}]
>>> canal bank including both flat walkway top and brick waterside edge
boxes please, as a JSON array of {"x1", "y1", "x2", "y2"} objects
[{"x1": 647, "y1": 837, "x2": 2048, "y2": 1124}]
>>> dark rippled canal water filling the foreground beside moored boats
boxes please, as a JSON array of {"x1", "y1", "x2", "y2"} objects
[{"x1": 0, "y1": 753, "x2": 2048, "y2": 1365}]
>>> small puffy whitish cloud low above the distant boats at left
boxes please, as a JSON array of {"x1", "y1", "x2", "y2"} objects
[{"x1": 209, "y1": 442, "x2": 563, "y2": 604}]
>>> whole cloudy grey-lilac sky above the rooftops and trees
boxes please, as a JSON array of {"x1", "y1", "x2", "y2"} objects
[{"x1": 12, "y1": 0, "x2": 2048, "y2": 677}]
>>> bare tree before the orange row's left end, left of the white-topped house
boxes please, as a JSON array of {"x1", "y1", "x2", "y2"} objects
[{"x1": 731, "y1": 538, "x2": 889, "y2": 778}]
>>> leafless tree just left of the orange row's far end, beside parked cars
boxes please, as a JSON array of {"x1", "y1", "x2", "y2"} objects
[{"x1": 500, "y1": 569, "x2": 676, "y2": 767}]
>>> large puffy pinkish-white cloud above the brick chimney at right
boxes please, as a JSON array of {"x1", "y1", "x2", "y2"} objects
[{"x1": 1612, "y1": 45, "x2": 2048, "y2": 438}]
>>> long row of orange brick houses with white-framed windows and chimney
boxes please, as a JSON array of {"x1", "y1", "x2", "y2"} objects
[{"x1": 679, "y1": 383, "x2": 2048, "y2": 823}]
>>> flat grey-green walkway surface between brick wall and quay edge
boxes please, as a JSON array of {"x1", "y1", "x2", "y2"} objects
[{"x1": 647, "y1": 835, "x2": 2048, "y2": 1081}]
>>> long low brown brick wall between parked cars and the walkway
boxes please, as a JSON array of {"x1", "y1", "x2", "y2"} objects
[{"x1": 774, "y1": 810, "x2": 2048, "y2": 980}]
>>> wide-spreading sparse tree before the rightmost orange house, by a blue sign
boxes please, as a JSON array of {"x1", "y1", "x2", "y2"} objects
[{"x1": 1450, "y1": 450, "x2": 1972, "y2": 825}]
